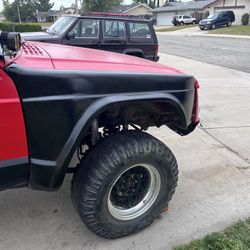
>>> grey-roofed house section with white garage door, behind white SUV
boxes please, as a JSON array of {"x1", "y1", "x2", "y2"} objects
[{"x1": 152, "y1": 0, "x2": 216, "y2": 25}]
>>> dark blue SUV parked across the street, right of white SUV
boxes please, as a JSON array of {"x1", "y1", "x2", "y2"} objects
[{"x1": 199, "y1": 11, "x2": 235, "y2": 30}]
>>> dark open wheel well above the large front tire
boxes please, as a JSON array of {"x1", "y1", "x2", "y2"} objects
[{"x1": 71, "y1": 101, "x2": 186, "y2": 169}]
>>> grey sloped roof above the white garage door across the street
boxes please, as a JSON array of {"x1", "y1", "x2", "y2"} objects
[{"x1": 152, "y1": 0, "x2": 217, "y2": 12}]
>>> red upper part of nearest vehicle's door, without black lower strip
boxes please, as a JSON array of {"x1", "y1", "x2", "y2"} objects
[{"x1": 0, "y1": 69, "x2": 28, "y2": 161}]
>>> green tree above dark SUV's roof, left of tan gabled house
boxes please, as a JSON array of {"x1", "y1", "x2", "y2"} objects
[{"x1": 82, "y1": 0, "x2": 123, "y2": 12}]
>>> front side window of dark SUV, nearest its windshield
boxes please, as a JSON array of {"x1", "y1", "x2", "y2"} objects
[{"x1": 72, "y1": 19, "x2": 99, "y2": 38}]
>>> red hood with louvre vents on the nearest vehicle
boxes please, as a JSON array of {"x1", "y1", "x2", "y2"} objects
[{"x1": 8, "y1": 42, "x2": 181, "y2": 74}]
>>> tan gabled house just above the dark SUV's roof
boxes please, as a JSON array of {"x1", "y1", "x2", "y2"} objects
[{"x1": 112, "y1": 4, "x2": 152, "y2": 16}]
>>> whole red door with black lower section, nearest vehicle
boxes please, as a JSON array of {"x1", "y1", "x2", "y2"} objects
[{"x1": 0, "y1": 69, "x2": 29, "y2": 190}]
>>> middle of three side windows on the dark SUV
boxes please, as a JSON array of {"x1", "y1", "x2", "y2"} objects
[{"x1": 103, "y1": 21, "x2": 126, "y2": 38}]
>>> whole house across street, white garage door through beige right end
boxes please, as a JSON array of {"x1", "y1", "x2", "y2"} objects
[{"x1": 152, "y1": 0, "x2": 250, "y2": 25}]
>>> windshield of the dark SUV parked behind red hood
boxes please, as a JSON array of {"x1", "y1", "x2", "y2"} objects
[{"x1": 47, "y1": 16, "x2": 76, "y2": 35}]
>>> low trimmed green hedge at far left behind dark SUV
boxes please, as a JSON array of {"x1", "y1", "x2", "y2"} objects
[{"x1": 0, "y1": 22, "x2": 42, "y2": 32}]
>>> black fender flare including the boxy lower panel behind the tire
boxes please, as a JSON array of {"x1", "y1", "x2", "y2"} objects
[{"x1": 29, "y1": 92, "x2": 187, "y2": 191}]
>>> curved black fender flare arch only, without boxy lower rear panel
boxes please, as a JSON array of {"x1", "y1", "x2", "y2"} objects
[{"x1": 51, "y1": 93, "x2": 187, "y2": 187}]
